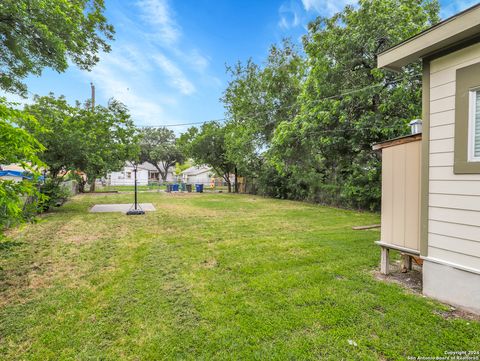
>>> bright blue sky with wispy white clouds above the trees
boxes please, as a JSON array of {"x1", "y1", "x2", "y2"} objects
[{"x1": 4, "y1": 0, "x2": 476, "y2": 132}]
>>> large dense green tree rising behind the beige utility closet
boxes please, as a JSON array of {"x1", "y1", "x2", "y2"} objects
[{"x1": 269, "y1": 0, "x2": 439, "y2": 209}]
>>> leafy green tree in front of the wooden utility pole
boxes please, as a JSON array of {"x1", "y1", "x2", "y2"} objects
[{"x1": 25, "y1": 94, "x2": 139, "y2": 192}]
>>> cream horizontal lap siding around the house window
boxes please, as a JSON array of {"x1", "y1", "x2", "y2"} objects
[{"x1": 428, "y1": 44, "x2": 480, "y2": 270}]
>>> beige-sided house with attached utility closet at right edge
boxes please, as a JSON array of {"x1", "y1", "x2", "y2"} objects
[{"x1": 374, "y1": 5, "x2": 480, "y2": 313}]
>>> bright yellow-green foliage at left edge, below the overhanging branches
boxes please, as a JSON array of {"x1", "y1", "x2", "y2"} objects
[{"x1": 0, "y1": 98, "x2": 44, "y2": 229}]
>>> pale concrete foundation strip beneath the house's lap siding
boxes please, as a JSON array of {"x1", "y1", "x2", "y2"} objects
[{"x1": 423, "y1": 258, "x2": 480, "y2": 314}]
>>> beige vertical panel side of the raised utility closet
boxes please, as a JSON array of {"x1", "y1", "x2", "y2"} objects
[{"x1": 381, "y1": 141, "x2": 421, "y2": 250}]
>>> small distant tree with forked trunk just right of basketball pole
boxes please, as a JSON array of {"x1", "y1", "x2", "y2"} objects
[{"x1": 140, "y1": 127, "x2": 184, "y2": 182}]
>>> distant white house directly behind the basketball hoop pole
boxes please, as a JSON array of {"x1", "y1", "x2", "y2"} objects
[{"x1": 107, "y1": 162, "x2": 175, "y2": 186}]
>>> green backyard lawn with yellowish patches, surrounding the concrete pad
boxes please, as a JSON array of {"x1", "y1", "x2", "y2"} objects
[{"x1": 0, "y1": 193, "x2": 480, "y2": 360}]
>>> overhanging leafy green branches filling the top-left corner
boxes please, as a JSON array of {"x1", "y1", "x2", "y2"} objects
[{"x1": 0, "y1": 0, "x2": 114, "y2": 95}]
